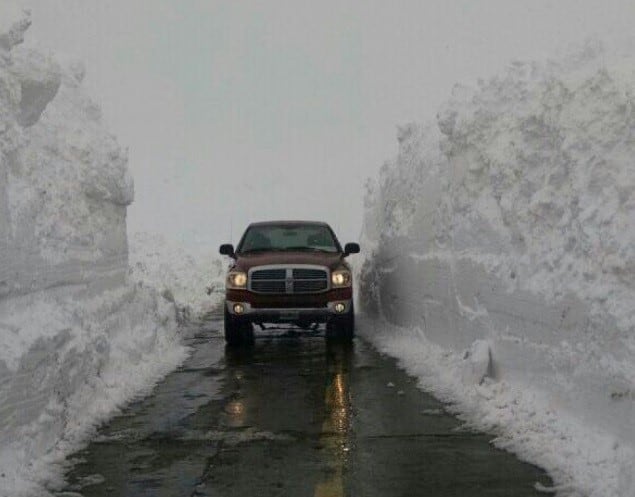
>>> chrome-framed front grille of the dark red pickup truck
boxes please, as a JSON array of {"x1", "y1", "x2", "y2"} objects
[{"x1": 248, "y1": 266, "x2": 329, "y2": 295}]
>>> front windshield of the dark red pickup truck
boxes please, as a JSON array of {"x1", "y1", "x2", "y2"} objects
[{"x1": 237, "y1": 225, "x2": 340, "y2": 254}]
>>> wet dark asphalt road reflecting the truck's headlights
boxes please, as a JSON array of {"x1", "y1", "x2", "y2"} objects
[{"x1": 60, "y1": 316, "x2": 551, "y2": 497}]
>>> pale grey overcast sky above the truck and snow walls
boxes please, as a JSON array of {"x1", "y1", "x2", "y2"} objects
[{"x1": 21, "y1": 0, "x2": 635, "y2": 246}]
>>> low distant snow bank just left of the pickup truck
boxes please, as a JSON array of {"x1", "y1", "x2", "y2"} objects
[{"x1": 130, "y1": 233, "x2": 225, "y2": 321}]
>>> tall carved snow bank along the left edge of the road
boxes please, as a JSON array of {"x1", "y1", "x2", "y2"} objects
[{"x1": 0, "y1": 8, "x2": 185, "y2": 497}]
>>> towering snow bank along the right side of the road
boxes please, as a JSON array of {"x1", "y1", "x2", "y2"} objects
[{"x1": 360, "y1": 39, "x2": 635, "y2": 497}]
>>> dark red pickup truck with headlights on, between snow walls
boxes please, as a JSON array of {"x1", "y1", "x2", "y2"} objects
[{"x1": 220, "y1": 221, "x2": 359, "y2": 345}]
